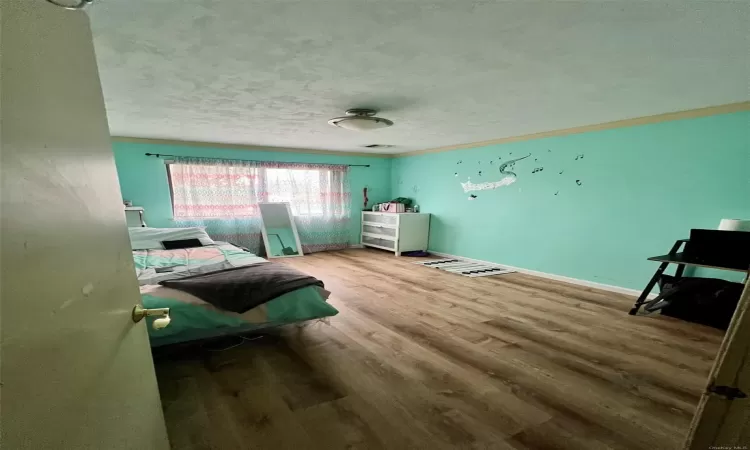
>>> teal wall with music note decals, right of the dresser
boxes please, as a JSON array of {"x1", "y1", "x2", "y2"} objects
[{"x1": 391, "y1": 112, "x2": 750, "y2": 289}]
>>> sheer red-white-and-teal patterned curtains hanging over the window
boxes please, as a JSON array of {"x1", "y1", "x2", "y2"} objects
[{"x1": 169, "y1": 157, "x2": 351, "y2": 254}]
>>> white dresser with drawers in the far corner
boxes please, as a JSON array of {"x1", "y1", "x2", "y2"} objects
[{"x1": 362, "y1": 211, "x2": 430, "y2": 256}]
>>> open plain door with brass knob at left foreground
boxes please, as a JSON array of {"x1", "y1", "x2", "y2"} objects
[{"x1": 0, "y1": 0, "x2": 169, "y2": 450}]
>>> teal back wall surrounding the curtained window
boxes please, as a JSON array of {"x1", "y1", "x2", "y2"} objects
[{"x1": 112, "y1": 142, "x2": 392, "y2": 243}]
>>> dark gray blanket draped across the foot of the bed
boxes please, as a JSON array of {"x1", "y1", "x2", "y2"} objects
[{"x1": 159, "y1": 262, "x2": 324, "y2": 313}]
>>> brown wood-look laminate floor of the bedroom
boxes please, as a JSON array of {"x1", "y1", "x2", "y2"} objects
[{"x1": 157, "y1": 250, "x2": 722, "y2": 450}]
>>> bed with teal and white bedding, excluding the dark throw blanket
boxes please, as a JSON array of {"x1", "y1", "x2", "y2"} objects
[{"x1": 131, "y1": 228, "x2": 338, "y2": 347}]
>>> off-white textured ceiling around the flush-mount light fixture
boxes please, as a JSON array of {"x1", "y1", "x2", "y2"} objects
[{"x1": 89, "y1": 0, "x2": 750, "y2": 153}]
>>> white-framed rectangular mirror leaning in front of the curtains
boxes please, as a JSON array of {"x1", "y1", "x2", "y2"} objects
[{"x1": 258, "y1": 202, "x2": 302, "y2": 258}]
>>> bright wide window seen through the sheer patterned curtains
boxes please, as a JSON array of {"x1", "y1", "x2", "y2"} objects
[{"x1": 167, "y1": 159, "x2": 349, "y2": 219}]
